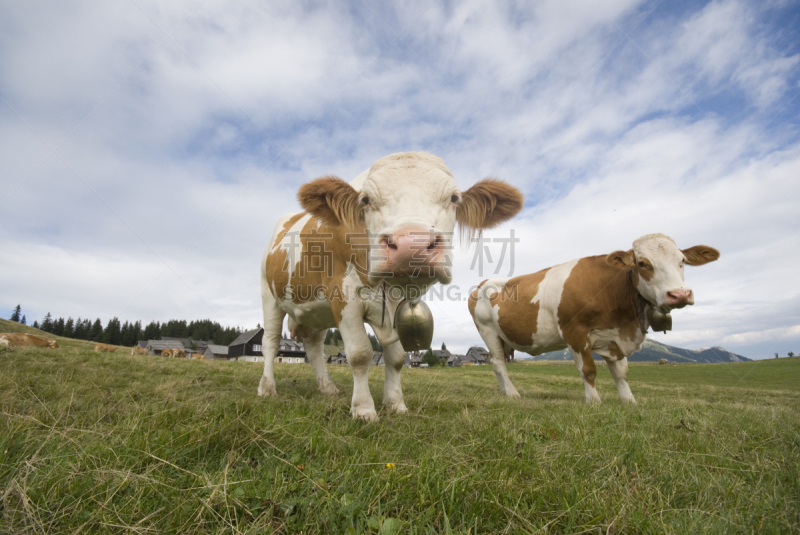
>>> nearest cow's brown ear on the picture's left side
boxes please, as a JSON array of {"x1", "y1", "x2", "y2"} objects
[{"x1": 297, "y1": 176, "x2": 361, "y2": 227}]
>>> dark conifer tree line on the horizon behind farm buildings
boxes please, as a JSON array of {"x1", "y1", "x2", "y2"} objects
[{"x1": 10, "y1": 305, "x2": 242, "y2": 346}]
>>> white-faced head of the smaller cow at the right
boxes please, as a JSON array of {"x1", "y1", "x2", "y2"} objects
[{"x1": 606, "y1": 234, "x2": 719, "y2": 312}]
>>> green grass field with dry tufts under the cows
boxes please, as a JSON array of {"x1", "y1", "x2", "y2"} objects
[{"x1": 0, "y1": 322, "x2": 800, "y2": 534}]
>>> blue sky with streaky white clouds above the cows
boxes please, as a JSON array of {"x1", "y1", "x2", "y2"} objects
[{"x1": 0, "y1": 0, "x2": 800, "y2": 358}]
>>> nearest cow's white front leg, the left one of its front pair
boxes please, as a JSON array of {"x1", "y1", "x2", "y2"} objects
[{"x1": 339, "y1": 318, "x2": 378, "y2": 422}]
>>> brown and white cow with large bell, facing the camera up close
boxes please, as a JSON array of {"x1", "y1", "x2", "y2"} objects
[{"x1": 258, "y1": 152, "x2": 523, "y2": 420}]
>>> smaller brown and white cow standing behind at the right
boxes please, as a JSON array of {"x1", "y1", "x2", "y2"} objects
[{"x1": 469, "y1": 234, "x2": 719, "y2": 403}]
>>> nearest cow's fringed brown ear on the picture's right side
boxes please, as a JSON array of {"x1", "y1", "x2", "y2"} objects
[{"x1": 456, "y1": 178, "x2": 524, "y2": 236}]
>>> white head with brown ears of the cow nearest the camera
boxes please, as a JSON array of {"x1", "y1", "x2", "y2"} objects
[{"x1": 298, "y1": 152, "x2": 523, "y2": 286}]
